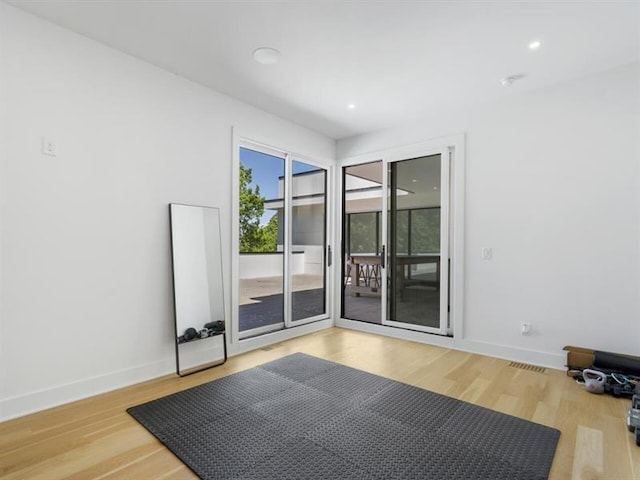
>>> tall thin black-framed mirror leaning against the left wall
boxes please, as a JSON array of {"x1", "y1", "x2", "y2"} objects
[{"x1": 169, "y1": 204, "x2": 227, "y2": 375}]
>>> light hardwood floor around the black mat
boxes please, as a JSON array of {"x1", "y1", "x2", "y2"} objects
[{"x1": 0, "y1": 328, "x2": 640, "y2": 480}]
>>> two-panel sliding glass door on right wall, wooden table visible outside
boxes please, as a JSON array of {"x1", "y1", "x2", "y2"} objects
[{"x1": 341, "y1": 152, "x2": 449, "y2": 335}]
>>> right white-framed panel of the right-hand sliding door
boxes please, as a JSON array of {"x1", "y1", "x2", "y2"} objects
[{"x1": 383, "y1": 154, "x2": 449, "y2": 334}]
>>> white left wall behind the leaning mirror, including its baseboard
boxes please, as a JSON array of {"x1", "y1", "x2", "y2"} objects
[{"x1": 0, "y1": 3, "x2": 335, "y2": 418}]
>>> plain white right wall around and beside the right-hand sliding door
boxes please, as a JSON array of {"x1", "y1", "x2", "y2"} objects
[{"x1": 337, "y1": 64, "x2": 640, "y2": 366}]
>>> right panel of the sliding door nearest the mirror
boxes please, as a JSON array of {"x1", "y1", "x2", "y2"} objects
[{"x1": 289, "y1": 160, "x2": 327, "y2": 324}]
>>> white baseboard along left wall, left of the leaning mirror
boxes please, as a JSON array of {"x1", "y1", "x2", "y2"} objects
[{"x1": 0, "y1": 357, "x2": 176, "y2": 421}]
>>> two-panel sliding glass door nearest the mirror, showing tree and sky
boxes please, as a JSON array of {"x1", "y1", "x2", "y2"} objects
[{"x1": 238, "y1": 145, "x2": 329, "y2": 338}]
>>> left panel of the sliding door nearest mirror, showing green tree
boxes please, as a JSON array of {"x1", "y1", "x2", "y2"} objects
[{"x1": 238, "y1": 147, "x2": 285, "y2": 338}]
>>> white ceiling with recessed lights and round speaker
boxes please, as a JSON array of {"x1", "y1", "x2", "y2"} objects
[{"x1": 7, "y1": 0, "x2": 640, "y2": 139}]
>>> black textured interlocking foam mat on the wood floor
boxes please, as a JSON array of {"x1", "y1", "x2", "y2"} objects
[{"x1": 127, "y1": 353, "x2": 560, "y2": 480}]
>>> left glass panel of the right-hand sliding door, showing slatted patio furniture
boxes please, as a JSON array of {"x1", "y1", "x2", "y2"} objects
[{"x1": 341, "y1": 161, "x2": 384, "y2": 324}]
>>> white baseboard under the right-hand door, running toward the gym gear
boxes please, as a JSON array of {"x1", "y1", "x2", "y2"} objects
[{"x1": 336, "y1": 318, "x2": 566, "y2": 370}]
